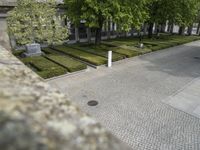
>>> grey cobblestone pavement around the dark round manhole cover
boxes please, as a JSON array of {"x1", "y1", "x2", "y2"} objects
[{"x1": 49, "y1": 41, "x2": 200, "y2": 150}]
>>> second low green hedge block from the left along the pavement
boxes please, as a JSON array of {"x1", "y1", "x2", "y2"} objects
[{"x1": 46, "y1": 55, "x2": 87, "y2": 72}]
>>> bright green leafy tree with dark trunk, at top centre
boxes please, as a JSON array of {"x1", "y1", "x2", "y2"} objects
[{"x1": 65, "y1": 0, "x2": 146, "y2": 44}]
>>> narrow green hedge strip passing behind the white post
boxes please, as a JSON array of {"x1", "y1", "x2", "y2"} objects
[{"x1": 68, "y1": 44, "x2": 126, "y2": 62}]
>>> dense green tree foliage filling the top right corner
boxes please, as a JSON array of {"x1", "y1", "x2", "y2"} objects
[{"x1": 148, "y1": 0, "x2": 200, "y2": 26}]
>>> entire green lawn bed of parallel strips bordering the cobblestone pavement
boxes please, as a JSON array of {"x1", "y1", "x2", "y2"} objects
[{"x1": 13, "y1": 34, "x2": 200, "y2": 79}]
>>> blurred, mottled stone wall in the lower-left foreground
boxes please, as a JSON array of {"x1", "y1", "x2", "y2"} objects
[{"x1": 0, "y1": 46, "x2": 130, "y2": 150}]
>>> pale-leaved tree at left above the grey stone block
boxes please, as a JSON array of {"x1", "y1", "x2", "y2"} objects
[{"x1": 7, "y1": 0, "x2": 68, "y2": 45}]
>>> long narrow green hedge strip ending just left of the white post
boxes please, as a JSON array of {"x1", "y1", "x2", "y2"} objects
[{"x1": 54, "y1": 45, "x2": 107, "y2": 66}]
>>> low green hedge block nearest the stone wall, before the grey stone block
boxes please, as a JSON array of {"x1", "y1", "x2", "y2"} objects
[{"x1": 21, "y1": 56, "x2": 67, "y2": 79}]
